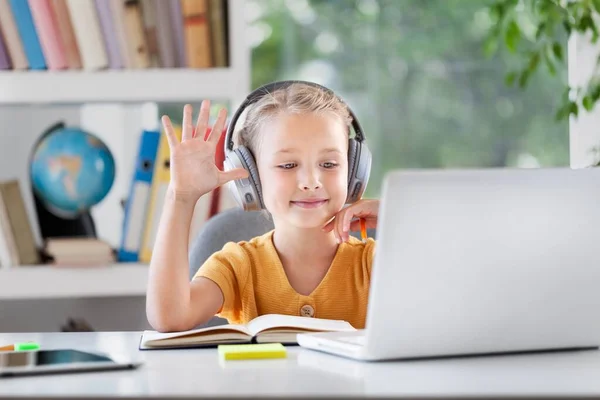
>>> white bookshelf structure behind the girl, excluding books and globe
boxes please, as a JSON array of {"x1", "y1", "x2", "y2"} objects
[{"x1": 0, "y1": 0, "x2": 251, "y2": 316}]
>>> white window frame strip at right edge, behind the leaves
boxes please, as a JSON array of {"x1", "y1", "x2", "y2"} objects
[{"x1": 568, "y1": 32, "x2": 600, "y2": 168}]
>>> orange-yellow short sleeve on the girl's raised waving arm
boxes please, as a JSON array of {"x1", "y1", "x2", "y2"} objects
[{"x1": 193, "y1": 242, "x2": 251, "y2": 321}]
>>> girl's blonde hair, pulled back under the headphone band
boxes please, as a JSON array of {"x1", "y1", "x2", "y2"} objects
[{"x1": 236, "y1": 83, "x2": 352, "y2": 156}]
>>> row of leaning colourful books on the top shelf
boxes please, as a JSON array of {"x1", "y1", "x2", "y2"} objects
[{"x1": 0, "y1": 0, "x2": 231, "y2": 70}]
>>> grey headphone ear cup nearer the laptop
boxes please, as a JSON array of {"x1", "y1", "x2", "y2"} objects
[{"x1": 346, "y1": 139, "x2": 372, "y2": 204}]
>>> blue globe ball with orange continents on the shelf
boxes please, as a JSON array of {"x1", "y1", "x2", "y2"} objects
[{"x1": 30, "y1": 127, "x2": 115, "y2": 218}]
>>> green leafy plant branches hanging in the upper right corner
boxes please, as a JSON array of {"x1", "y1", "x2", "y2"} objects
[{"x1": 483, "y1": 0, "x2": 600, "y2": 119}]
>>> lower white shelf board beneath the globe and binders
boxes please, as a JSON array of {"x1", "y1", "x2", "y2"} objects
[{"x1": 0, "y1": 263, "x2": 148, "y2": 300}]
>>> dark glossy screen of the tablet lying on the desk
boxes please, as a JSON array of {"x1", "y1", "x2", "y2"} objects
[{"x1": 0, "y1": 349, "x2": 113, "y2": 368}]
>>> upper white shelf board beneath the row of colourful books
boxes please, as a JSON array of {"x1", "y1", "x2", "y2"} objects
[{"x1": 0, "y1": 68, "x2": 247, "y2": 105}]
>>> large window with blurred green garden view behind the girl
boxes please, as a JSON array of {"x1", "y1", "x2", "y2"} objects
[{"x1": 247, "y1": 0, "x2": 569, "y2": 196}]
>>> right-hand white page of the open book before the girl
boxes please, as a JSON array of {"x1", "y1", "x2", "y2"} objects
[{"x1": 247, "y1": 314, "x2": 356, "y2": 336}]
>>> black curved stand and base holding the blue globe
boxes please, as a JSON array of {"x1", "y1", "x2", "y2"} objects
[{"x1": 29, "y1": 122, "x2": 97, "y2": 241}]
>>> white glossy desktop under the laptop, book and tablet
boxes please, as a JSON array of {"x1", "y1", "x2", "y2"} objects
[{"x1": 0, "y1": 332, "x2": 600, "y2": 398}]
